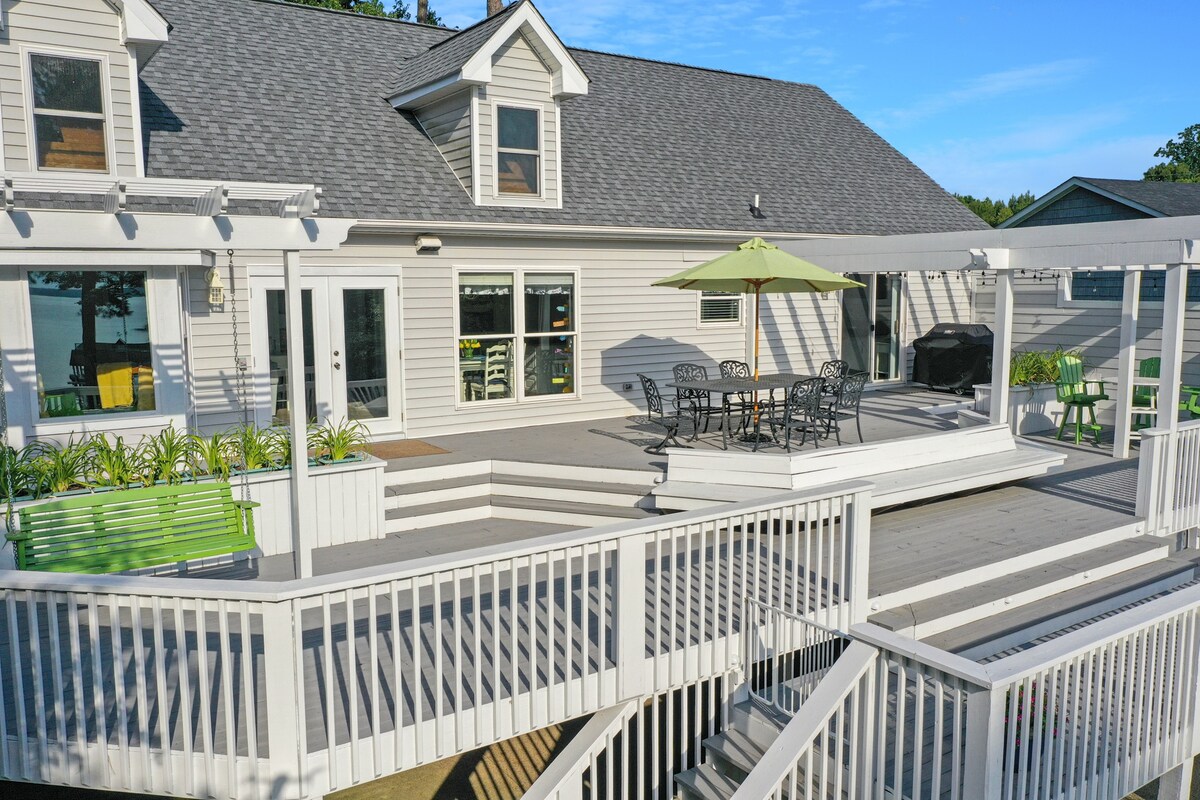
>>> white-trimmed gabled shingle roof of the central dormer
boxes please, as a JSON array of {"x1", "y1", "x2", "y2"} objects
[{"x1": 385, "y1": 0, "x2": 588, "y2": 109}]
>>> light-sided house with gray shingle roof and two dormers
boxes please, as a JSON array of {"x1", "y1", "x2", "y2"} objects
[{"x1": 0, "y1": 0, "x2": 980, "y2": 448}]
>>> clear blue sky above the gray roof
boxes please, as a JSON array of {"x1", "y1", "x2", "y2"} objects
[{"x1": 432, "y1": 0, "x2": 1200, "y2": 198}]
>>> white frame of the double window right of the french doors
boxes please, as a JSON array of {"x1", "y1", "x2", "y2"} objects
[{"x1": 450, "y1": 264, "x2": 583, "y2": 411}]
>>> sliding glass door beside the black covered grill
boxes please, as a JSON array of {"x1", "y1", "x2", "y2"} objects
[{"x1": 841, "y1": 272, "x2": 904, "y2": 383}]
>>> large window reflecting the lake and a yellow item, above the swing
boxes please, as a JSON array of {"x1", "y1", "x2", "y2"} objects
[{"x1": 29, "y1": 270, "x2": 156, "y2": 419}]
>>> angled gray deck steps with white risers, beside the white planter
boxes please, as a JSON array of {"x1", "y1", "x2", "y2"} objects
[{"x1": 384, "y1": 461, "x2": 658, "y2": 534}]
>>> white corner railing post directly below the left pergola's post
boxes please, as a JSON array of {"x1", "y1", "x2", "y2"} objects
[{"x1": 263, "y1": 601, "x2": 306, "y2": 798}]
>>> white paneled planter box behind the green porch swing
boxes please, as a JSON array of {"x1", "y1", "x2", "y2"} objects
[{"x1": 0, "y1": 456, "x2": 386, "y2": 570}]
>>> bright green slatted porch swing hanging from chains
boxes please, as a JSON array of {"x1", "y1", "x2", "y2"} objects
[{"x1": 0, "y1": 251, "x2": 259, "y2": 575}]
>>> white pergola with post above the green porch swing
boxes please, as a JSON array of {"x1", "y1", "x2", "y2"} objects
[{"x1": 0, "y1": 173, "x2": 358, "y2": 577}]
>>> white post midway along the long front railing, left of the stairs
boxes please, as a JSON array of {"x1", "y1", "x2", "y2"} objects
[{"x1": 612, "y1": 536, "x2": 648, "y2": 700}]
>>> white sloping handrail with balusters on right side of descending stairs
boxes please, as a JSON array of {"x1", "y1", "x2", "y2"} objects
[{"x1": 731, "y1": 642, "x2": 880, "y2": 800}]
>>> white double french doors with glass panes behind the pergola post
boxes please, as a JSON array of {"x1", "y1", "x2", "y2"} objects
[{"x1": 251, "y1": 276, "x2": 403, "y2": 435}]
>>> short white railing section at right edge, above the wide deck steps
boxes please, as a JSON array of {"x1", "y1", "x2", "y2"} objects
[{"x1": 1138, "y1": 420, "x2": 1200, "y2": 536}]
